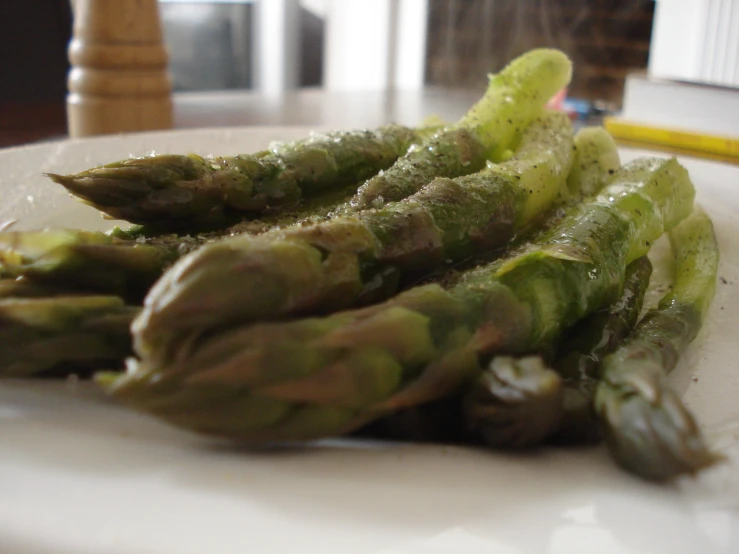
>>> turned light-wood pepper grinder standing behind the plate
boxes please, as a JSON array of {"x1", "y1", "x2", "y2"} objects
[{"x1": 67, "y1": 0, "x2": 172, "y2": 137}]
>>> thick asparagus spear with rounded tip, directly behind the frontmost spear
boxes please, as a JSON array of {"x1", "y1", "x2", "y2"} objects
[{"x1": 134, "y1": 112, "x2": 572, "y2": 358}]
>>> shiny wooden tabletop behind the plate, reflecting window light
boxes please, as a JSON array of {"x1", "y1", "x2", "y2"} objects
[{"x1": 0, "y1": 88, "x2": 482, "y2": 147}]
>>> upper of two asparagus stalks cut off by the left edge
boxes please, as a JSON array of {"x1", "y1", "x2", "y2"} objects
[{"x1": 0, "y1": 184, "x2": 356, "y2": 303}]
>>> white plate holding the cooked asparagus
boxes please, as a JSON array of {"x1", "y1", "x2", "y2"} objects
[{"x1": 0, "y1": 128, "x2": 739, "y2": 554}]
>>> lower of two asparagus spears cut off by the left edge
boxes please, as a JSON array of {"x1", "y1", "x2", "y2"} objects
[{"x1": 0, "y1": 296, "x2": 138, "y2": 377}]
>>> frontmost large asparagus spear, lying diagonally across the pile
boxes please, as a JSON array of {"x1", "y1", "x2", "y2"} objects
[{"x1": 98, "y1": 155, "x2": 694, "y2": 442}]
